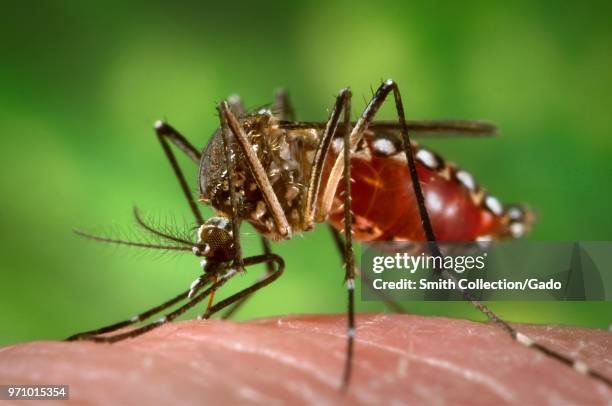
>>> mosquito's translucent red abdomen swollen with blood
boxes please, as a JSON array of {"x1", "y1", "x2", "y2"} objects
[{"x1": 329, "y1": 141, "x2": 502, "y2": 241}]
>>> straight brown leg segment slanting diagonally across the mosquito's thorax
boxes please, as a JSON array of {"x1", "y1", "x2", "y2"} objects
[{"x1": 219, "y1": 102, "x2": 291, "y2": 239}]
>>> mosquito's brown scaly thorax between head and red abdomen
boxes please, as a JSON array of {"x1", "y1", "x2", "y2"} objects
[{"x1": 199, "y1": 110, "x2": 318, "y2": 240}]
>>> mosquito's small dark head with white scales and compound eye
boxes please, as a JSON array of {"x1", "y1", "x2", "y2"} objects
[{"x1": 193, "y1": 217, "x2": 235, "y2": 262}]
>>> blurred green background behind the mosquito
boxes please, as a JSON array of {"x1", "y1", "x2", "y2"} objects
[{"x1": 0, "y1": 1, "x2": 612, "y2": 344}]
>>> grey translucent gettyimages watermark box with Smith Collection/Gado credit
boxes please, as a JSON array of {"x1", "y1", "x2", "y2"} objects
[{"x1": 361, "y1": 241, "x2": 612, "y2": 301}]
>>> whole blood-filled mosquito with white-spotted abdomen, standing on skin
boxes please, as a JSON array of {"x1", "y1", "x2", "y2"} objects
[{"x1": 68, "y1": 80, "x2": 612, "y2": 389}]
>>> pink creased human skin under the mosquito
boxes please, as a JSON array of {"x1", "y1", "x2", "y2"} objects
[{"x1": 0, "y1": 314, "x2": 612, "y2": 405}]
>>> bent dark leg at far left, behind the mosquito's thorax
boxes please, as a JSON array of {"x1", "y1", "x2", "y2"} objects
[{"x1": 155, "y1": 121, "x2": 204, "y2": 225}]
